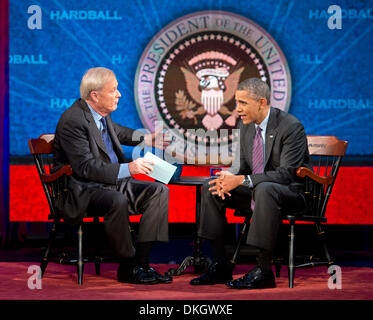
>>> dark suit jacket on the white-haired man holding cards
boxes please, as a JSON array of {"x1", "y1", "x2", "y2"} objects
[{"x1": 53, "y1": 99, "x2": 143, "y2": 224}]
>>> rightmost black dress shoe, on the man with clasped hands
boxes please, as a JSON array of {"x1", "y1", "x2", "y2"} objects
[{"x1": 226, "y1": 267, "x2": 276, "y2": 289}]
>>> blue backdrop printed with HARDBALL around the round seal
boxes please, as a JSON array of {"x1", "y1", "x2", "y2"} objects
[{"x1": 9, "y1": 0, "x2": 373, "y2": 156}]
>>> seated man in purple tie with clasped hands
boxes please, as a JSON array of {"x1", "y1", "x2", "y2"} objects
[{"x1": 191, "y1": 78, "x2": 312, "y2": 289}]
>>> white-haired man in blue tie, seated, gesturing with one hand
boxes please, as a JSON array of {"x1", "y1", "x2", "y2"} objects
[{"x1": 54, "y1": 68, "x2": 172, "y2": 284}]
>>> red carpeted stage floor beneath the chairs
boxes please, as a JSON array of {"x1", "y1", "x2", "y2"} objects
[{"x1": 0, "y1": 261, "x2": 373, "y2": 300}]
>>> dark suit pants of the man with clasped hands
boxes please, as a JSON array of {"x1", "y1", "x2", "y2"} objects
[{"x1": 198, "y1": 182, "x2": 304, "y2": 250}]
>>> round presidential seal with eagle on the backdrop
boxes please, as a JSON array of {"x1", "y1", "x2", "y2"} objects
[{"x1": 135, "y1": 11, "x2": 291, "y2": 164}]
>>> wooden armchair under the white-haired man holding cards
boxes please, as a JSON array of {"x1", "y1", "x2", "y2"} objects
[{"x1": 28, "y1": 134, "x2": 101, "y2": 285}]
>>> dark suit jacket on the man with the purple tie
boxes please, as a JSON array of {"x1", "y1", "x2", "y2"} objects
[{"x1": 230, "y1": 107, "x2": 312, "y2": 188}]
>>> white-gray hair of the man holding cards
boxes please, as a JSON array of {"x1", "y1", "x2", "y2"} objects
[{"x1": 80, "y1": 67, "x2": 115, "y2": 100}]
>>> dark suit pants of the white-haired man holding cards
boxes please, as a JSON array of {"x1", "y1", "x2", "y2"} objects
[{"x1": 87, "y1": 177, "x2": 168, "y2": 258}]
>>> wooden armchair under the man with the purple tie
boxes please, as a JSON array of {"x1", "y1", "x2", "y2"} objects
[{"x1": 231, "y1": 135, "x2": 348, "y2": 288}]
